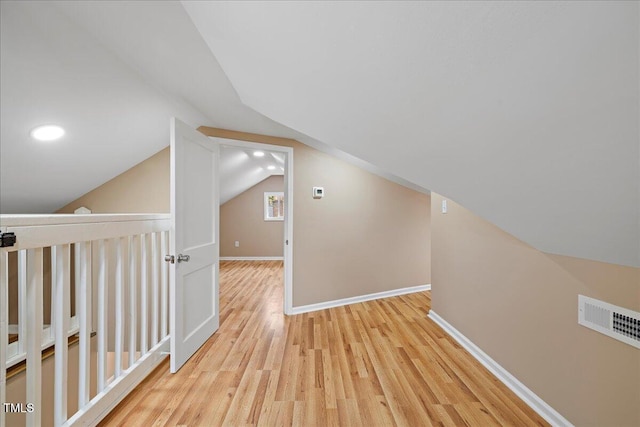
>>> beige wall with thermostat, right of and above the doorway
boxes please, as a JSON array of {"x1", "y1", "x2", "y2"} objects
[{"x1": 199, "y1": 127, "x2": 431, "y2": 307}]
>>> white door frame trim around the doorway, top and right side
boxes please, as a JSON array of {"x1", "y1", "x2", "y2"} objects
[{"x1": 209, "y1": 136, "x2": 293, "y2": 315}]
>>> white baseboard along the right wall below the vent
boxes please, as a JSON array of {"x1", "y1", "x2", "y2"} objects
[{"x1": 429, "y1": 310, "x2": 573, "y2": 427}]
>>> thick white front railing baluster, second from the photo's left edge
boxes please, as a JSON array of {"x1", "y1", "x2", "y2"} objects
[{"x1": 25, "y1": 248, "x2": 44, "y2": 426}]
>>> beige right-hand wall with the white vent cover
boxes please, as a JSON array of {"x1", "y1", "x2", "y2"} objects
[{"x1": 431, "y1": 194, "x2": 640, "y2": 426}]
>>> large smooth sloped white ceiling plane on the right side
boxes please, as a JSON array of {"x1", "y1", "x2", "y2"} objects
[{"x1": 183, "y1": 2, "x2": 640, "y2": 266}]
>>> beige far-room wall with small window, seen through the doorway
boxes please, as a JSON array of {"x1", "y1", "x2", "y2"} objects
[{"x1": 220, "y1": 175, "x2": 284, "y2": 257}]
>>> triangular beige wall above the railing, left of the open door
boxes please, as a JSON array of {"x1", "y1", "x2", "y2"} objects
[{"x1": 57, "y1": 147, "x2": 171, "y2": 213}]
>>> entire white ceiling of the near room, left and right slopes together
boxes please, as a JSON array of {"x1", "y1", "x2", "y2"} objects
[{"x1": 0, "y1": 1, "x2": 640, "y2": 265}]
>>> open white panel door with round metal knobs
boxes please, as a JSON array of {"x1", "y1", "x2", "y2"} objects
[{"x1": 169, "y1": 118, "x2": 220, "y2": 373}]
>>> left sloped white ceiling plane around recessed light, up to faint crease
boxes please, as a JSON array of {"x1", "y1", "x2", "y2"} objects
[{"x1": 0, "y1": 1, "x2": 207, "y2": 213}]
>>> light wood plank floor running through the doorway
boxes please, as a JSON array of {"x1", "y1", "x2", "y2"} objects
[{"x1": 102, "y1": 261, "x2": 547, "y2": 426}]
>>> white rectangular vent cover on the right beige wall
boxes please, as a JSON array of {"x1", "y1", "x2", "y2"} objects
[{"x1": 578, "y1": 295, "x2": 640, "y2": 349}]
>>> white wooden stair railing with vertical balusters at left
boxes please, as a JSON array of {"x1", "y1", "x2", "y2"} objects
[{"x1": 0, "y1": 214, "x2": 171, "y2": 427}]
